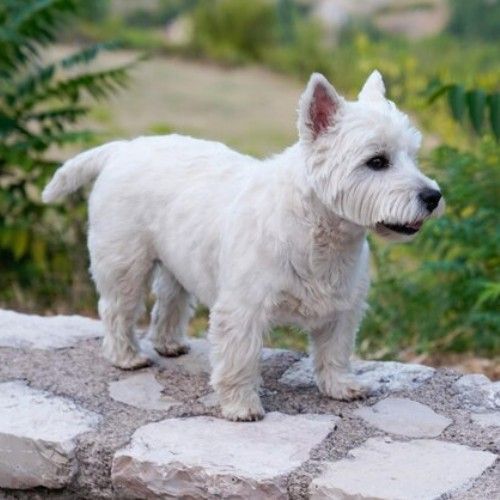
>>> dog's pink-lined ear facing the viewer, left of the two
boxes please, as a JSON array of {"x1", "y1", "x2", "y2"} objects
[{"x1": 298, "y1": 73, "x2": 343, "y2": 141}]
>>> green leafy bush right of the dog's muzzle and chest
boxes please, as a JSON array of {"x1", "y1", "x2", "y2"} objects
[{"x1": 361, "y1": 139, "x2": 500, "y2": 357}]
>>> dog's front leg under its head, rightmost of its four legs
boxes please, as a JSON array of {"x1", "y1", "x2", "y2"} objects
[{"x1": 311, "y1": 311, "x2": 366, "y2": 400}]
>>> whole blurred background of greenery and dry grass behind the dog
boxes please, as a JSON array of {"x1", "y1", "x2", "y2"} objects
[{"x1": 0, "y1": 0, "x2": 500, "y2": 378}]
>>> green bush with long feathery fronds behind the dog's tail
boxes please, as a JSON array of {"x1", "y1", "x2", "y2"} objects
[{"x1": 0, "y1": 0, "x2": 134, "y2": 308}]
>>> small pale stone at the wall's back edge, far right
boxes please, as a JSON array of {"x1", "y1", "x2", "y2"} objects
[{"x1": 454, "y1": 374, "x2": 500, "y2": 411}]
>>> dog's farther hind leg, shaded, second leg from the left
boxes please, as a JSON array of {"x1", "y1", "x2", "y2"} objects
[{"x1": 148, "y1": 264, "x2": 191, "y2": 356}]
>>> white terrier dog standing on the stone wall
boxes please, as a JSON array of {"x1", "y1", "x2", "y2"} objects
[{"x1": 43, "y1": 71, "x2": 443, "y2": 420}]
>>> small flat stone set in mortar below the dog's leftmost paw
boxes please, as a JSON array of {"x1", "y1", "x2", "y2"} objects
[{"x1": 109, "y1": 372, "x2": 181, "y2": 410}]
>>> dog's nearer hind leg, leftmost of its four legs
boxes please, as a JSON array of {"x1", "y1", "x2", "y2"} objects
[{"x1": 89, "y1": 239, "x2": 152, "y2": 370}]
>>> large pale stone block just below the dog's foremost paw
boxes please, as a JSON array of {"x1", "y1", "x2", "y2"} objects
[{"x1": 112, "y1": 412, "x2": 338, "y2": 499}]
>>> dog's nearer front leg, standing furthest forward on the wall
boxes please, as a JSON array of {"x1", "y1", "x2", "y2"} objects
[{"x1": 208, "y1": 306, "x2": 265, "y2": 421}]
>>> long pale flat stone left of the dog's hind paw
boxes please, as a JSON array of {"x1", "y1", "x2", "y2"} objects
[{"x1": 0, "y1": 309, "x2": 104, "y2": 350}]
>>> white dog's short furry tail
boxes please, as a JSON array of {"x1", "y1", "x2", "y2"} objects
[{"x1": 42, "y1": 141, "x2": 126, "y2": 203}]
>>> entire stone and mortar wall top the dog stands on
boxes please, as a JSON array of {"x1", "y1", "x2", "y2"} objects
[{"x1": 0, "y1": 311, "x2": 500, "y2": 500}]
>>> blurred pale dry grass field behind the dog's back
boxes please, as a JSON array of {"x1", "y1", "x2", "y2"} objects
[{"x1": 63, "y1": 47, "x2": 302, "y2": 156}]
